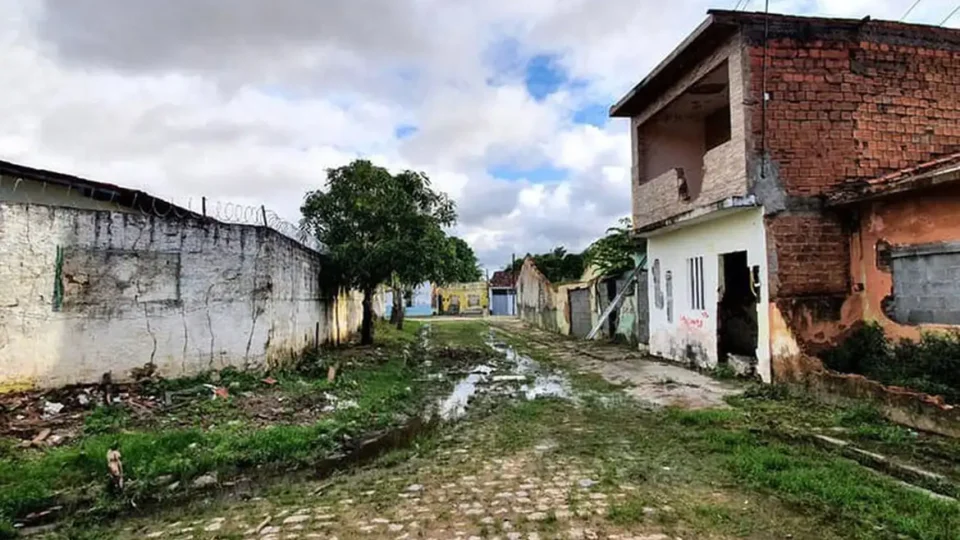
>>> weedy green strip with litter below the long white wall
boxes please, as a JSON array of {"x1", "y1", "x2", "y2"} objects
[{"x1": 0, "y1": 325, "x2": 442, "y2": 537}]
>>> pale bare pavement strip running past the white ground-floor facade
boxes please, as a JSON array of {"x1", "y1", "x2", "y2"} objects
[{"x1": 491, "y1": 319, "x2": 742, "y2": 409}]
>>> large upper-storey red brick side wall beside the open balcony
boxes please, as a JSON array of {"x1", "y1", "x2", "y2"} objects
[{"x1": 746, "y1": 23, "x2": 960, "y2": 197}]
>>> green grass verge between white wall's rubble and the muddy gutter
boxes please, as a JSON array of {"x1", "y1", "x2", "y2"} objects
[{"x1": 0, "y1": 326, "x2": 424, "y2": 537}]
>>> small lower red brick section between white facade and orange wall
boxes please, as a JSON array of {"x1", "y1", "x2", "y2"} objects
[{"x1": 766, "y1": 213, "x2": 850, "y2": 297}]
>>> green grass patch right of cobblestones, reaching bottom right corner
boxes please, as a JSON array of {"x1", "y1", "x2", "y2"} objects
[{"x1": 478, "y1": 382, "x2": 960, "y2": 540}]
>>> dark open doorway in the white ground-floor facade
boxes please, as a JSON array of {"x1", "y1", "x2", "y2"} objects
[{"x1": 717, "y1": 251, "x2": 758, "y2": 362}]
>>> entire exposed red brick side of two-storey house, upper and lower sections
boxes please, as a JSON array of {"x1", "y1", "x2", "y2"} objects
[{"x1": 743, "y1": 18, "x2": 960, "y2": 310}]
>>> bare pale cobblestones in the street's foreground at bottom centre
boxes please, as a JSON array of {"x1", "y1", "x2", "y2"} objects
[{"x1": 129, "y1": 443, "x2": 670, "y2": 540}]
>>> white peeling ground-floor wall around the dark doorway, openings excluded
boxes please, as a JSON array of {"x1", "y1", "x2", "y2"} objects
[{"x1": 647, "y1": 208, "x2": 771, "y2": 381}]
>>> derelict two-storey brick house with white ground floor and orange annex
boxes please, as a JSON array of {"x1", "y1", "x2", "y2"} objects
[{"x1": 610, "y1": 11, "x2": 960, "y2": 381}]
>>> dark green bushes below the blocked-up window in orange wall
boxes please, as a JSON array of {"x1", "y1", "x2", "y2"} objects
[{"x1": 822, "y1": 323, "x2": 960, "y2": 403}]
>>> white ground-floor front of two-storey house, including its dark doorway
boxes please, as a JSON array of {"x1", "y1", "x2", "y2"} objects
[{"x1": 647, "y1": 207, "x2": 770, "y2": 375}]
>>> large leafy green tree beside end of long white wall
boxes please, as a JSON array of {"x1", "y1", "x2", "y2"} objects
[{"x1": 300, "y1": 160, "x2": 456, "y2": 344}]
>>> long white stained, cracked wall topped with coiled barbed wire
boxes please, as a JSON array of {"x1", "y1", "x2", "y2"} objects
[{"x1": 0, "y1": 202, "x2": 362, "y2": 387}]
